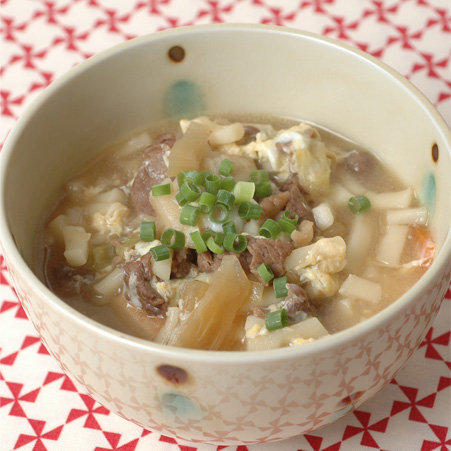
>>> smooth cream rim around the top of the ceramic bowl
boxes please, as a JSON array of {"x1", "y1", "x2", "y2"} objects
[{"x1": 0, "y1": 23, "x2": 451, "y2": 365}]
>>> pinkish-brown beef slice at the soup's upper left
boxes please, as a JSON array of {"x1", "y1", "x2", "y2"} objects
[{"x1": 131, "y1": 134, "x2": 176, "y2": 216}]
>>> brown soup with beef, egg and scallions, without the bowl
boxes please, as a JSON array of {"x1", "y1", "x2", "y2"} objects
[{"x1": 36, "y1": 116, "x2": 435, "y2": 350}]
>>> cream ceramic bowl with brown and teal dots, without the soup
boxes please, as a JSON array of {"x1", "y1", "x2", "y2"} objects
[{"x1": 0, "y1": 25, "x2": 451, "y2": 444}]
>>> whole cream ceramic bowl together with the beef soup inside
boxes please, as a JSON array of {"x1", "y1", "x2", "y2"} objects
[{"x1": 0, "y1": 25, "x2": 451, "y2": 444}]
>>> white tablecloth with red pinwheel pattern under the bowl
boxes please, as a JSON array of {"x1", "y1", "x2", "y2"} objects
[{"x1": 0, "y1": 0, "x2": 451, "y2": 451}]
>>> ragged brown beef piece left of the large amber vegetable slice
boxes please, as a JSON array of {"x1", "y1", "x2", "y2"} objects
[{"x1": 122, "y1": 253, "x2": 167, "y2": 316}]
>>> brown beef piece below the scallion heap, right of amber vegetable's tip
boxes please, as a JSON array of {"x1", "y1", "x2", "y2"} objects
[{"x1": 246, "y1": 236, "x2": 294, "y2": 280}]
